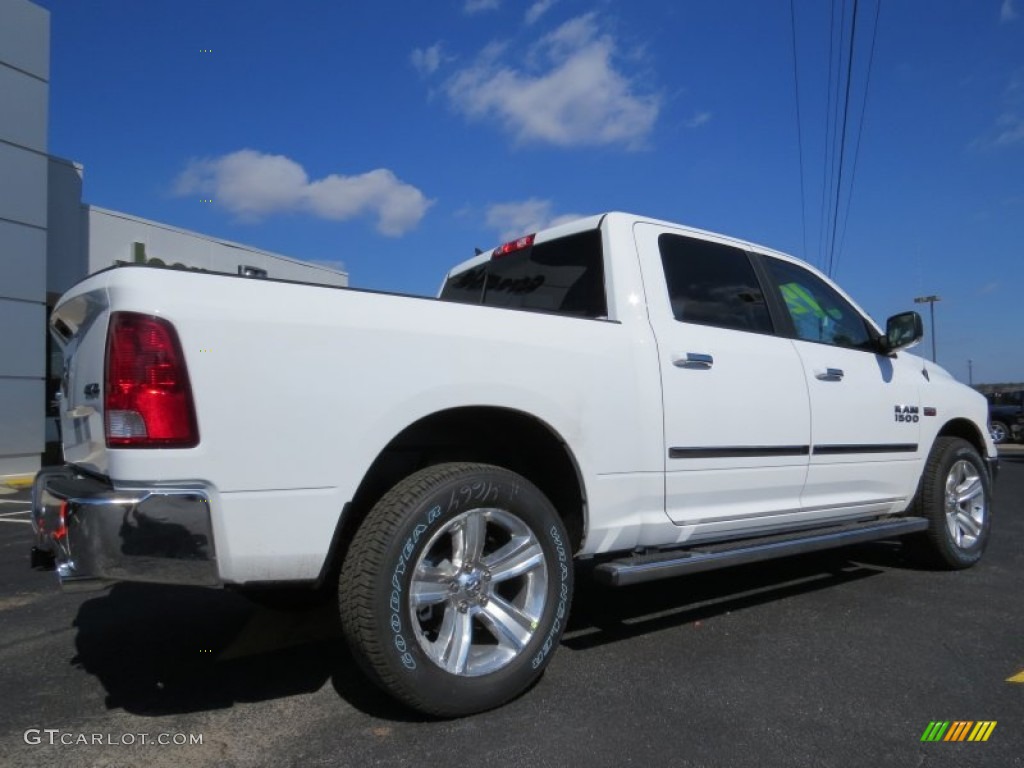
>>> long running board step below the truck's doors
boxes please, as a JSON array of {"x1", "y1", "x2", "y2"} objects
[{"x1": 594, "y1": 517, "x2": 928, "y2": 587}]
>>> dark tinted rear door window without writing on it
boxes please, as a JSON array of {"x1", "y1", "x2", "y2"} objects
[{"x1": 657, "y1": 234, "x2": 772, "y2": 333}]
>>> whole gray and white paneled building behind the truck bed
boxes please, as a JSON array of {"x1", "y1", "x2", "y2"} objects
[{"x1": 0, "y1": 0, "x2": 348, "y2": 483}]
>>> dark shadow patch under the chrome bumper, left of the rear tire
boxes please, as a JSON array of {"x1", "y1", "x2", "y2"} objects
[{"x1": 71, "y1": 584, "x2": 416, "y2": 720}]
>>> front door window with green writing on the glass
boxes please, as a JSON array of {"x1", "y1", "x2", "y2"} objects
[{"x1": 765, "y1": 258, "x2": 874, "y2": 350}]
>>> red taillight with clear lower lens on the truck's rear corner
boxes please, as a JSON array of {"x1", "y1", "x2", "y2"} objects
[{"x1": 104, "y1": 312, "x2": 199, "y2": 447}]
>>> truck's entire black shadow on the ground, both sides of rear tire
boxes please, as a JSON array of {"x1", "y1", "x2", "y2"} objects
[{"x1": 71, "y1": 545, "x2": 899, "y2": 721}]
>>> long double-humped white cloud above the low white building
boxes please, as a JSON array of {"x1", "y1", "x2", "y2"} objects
[{"x1": 174, "y1": 150, "x2": 433, "y2": 237}]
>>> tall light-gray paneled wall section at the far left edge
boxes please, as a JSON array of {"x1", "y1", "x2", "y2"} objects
[{"x1": 0, "y1": 0, "x2": 50, "y2": 480}]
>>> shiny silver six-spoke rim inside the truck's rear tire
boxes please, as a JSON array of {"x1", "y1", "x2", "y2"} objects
[{"x1": 409, "y1": 508, "x2": 548, "y2": 677}]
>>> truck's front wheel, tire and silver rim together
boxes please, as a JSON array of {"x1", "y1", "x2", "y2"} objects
[{"x1": 907, "y1": 437, "x2": 992, "y2": 569}]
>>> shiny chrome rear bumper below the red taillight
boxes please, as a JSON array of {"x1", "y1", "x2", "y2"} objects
[{"x1": 32, "y1": 467, "x2": 220, "y2": 587}]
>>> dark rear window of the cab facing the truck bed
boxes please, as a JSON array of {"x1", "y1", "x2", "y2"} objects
[{"x1": 440, "y1": 229, "x2": 608, "y2": 317}]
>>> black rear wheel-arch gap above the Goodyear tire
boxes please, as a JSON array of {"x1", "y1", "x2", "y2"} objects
[{"x1": 322, "y1": 406, "x2": 587, "y2": 579}]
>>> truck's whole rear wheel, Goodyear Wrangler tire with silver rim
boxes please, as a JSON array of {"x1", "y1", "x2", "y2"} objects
[{"x1": 338, "y1": 463, "x2": 573, "y2": 717}]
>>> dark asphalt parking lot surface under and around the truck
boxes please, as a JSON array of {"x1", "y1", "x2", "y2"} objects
[{"x1": 0, "y1": 449, "x2": 1024, "y2": 768}]
